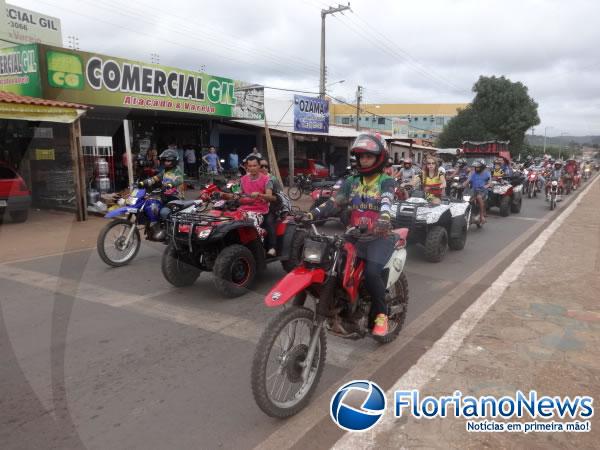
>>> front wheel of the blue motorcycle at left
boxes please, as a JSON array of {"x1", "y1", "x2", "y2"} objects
[{"x1": 96, "y1": 219, "x2": 142, "y2": 267}]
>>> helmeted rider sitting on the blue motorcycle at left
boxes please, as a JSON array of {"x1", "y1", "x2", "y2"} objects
[{"x1": 139, "y1": 148, "x2": 183, "y2": 240}]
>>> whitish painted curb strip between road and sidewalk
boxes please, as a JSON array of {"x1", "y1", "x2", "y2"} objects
[{"x1": 332, "y1": 171, "x2": 599, "y2": 449}]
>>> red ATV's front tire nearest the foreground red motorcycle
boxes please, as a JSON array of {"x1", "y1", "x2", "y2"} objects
[{"x1": 213, "y1": 244, "x2": 256, "y2": 298}]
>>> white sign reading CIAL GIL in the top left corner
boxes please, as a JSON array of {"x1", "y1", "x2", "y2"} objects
[{"x1": 0, "y1": 0, "x2": 63, "y2": 46}]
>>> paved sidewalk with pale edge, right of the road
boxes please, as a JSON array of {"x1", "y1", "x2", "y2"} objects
[{"x1": 337, "y1": 180, "x2": 600, "y2": 449}]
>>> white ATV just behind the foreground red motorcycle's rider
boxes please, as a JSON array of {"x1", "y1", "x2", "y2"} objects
[{"x1": 392, "y1": 191, "x2": 471, "y2": 262}]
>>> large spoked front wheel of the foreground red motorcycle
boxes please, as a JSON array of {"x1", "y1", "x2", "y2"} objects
[{"x1": 251, "y1": 307, "x2": 327, "y2": 418}]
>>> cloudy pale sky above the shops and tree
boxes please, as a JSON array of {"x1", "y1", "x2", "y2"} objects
[{"x1": 14, "y1": 0, "x2": 600, "y2": 136}]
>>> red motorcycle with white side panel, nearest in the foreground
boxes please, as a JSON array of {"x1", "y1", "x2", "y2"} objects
[{"x1": 251, "y1": 223, "x2": 408, "y2": 418}]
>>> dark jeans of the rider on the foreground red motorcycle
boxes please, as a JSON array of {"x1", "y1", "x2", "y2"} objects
[{"x1": 356, "y1": 237, "x2": 394, "y2": 320}]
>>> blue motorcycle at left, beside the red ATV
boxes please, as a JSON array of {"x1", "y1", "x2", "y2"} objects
[{"x1": 96, "y1": 188, "x2": 194, "y2": 267}]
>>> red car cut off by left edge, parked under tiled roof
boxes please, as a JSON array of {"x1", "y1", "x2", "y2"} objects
[{"x1": 0, "y1": 163, "x2": 31, "y2": 222}]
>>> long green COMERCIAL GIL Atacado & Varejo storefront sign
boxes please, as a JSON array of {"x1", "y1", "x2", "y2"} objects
[{"x1": 40, "y1": 45, "x2": 264, "y2": 119}]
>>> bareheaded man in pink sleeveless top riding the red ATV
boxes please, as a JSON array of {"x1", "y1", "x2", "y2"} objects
[{"x1": 221, "y1": 155, "x2": 277, "y2": 256}]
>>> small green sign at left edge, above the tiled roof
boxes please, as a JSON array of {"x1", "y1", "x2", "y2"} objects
[{"x1": 0, "y1": 44, "x2": 42, "y2": 97}]
